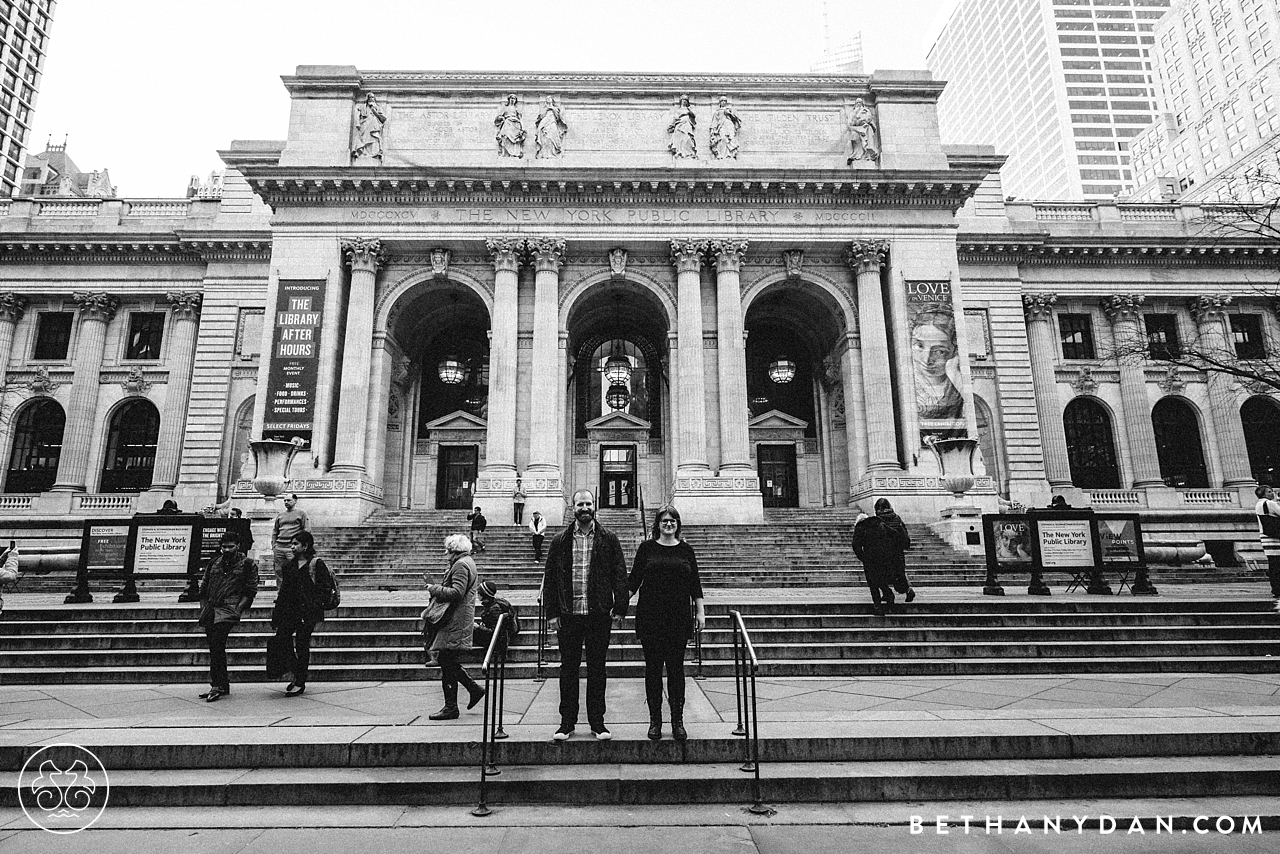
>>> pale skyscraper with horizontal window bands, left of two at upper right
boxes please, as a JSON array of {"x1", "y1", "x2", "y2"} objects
[{"x1": 928, "y1": 0, "x2": 1170, "y2": 200}]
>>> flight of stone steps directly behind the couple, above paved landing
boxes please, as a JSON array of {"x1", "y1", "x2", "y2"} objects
[{"x1": 0, "y1": 595, "x2": 1280, "y2": 685}]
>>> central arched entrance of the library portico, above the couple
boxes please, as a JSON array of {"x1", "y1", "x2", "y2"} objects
[{"x1": 566, "y1": 280, "x2": 671, "y2": 510}]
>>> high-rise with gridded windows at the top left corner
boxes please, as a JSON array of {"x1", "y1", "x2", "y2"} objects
[{"x1": 0, "y1": 0, "x2": 58, "y2": 197}]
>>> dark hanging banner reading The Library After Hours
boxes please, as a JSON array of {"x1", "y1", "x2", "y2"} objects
[{"x1": 262, "y1": 279, "x2": 325, "y2": 440}]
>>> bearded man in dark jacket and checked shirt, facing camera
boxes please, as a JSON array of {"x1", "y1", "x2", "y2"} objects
[{"x1": 543, "y1": 489, "x2": 631, "y2": 741}]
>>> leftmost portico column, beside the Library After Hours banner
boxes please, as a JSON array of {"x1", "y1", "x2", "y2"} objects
[{"x1": 333, "y1": 238, "x2": 385, "y2": 474}]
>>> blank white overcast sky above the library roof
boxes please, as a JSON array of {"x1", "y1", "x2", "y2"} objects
[{"x1": 28, "y1": 0, "x2": 957, "y2": 198}]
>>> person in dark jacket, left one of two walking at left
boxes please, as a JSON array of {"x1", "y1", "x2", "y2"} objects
[{"x1": 197, "y1": 531, "x2": 257, "y2": 703}]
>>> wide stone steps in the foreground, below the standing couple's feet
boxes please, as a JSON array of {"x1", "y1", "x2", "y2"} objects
[{"x1": 0, "y1": 723, "x2": 1280, "y2": 808}]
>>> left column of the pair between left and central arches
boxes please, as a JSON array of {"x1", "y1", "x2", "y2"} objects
[{"x1": 476, "y1": 237, "x2": 525, "y2": 491}]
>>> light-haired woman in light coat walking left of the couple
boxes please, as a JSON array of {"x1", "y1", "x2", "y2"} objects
[{"x1": 426, "y1": 534, "x2": 485, "y2": 721}]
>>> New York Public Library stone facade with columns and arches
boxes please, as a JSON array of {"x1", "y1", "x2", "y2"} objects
[{"x1": 0, "y1": 67, "x2": 1280, "y2": 560}]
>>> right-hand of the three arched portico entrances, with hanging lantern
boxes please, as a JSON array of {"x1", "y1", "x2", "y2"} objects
[{"x1": 747, "y1": 279, "x2": 851, "y2": 507}]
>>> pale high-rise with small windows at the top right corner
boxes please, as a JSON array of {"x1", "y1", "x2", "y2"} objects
[{"x1": 1133, "y1": 0, "x2": 1280, "y2": 200}]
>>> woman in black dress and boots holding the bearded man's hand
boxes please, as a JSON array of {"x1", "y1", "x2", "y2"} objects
[{"x1": 627, "y1": 507, "x2": 707, "y2": 741}]
